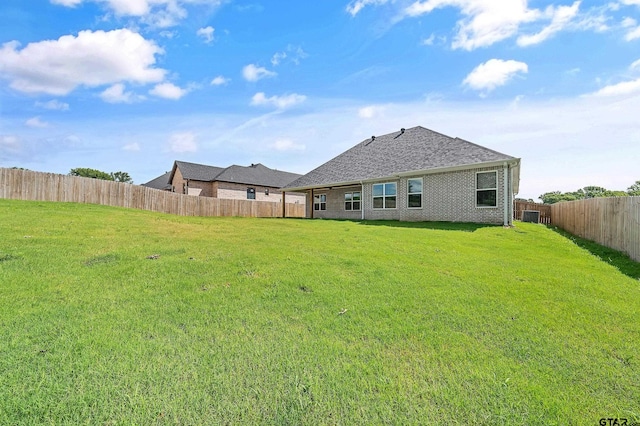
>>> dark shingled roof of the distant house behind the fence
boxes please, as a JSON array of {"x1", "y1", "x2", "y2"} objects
[{"x1": 168, "y1": 161, "x2": 301, "y2": 188}]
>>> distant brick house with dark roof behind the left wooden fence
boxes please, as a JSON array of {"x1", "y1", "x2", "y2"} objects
[{"x1": 144, "y1": 161, "x2": 305, "y2": 203}]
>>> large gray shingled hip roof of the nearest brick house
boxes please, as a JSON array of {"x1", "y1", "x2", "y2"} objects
[{"x1": 286, "y1": 126, "x2": 516, "y2": 189}]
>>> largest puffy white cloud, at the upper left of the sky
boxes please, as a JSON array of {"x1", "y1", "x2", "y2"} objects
[{"x1": 0, "y1": 29, "x2": 166, "y2": 95}]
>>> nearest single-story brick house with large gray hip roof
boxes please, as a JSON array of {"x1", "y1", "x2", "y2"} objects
[{"x1": 283, "y1": 127, "x2": 520, "y2": 225}]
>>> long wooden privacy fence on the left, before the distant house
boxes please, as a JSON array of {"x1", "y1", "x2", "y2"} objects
[{"x1": 0, "y1": 168, "x2": 305, "y2": 217}]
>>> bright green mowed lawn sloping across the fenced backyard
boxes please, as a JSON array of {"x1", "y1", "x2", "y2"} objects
[{"x1": 0, "y1": 200, "x2": 640, "y2": 425}]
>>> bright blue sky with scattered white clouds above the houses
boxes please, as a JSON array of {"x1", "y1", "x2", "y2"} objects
[{"x1": 0, "y1": 0, "x2": 640, "y2": 199}]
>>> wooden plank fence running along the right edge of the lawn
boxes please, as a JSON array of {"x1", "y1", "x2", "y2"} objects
[{"x1": 551, "y1": 197, "x2": 640, "y2": 262}]
